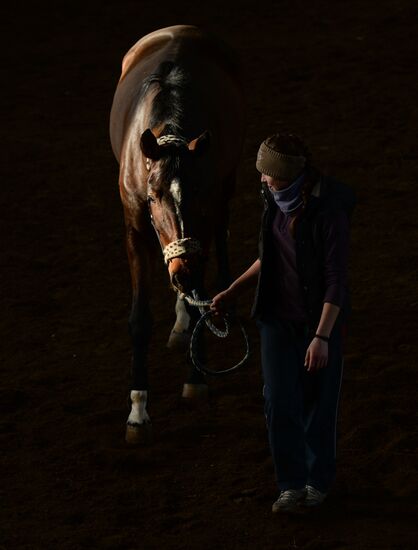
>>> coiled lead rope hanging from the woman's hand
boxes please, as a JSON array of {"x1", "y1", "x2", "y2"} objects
[{"x1": 180, "y1": 290, "x2": 250, "y2": 376}]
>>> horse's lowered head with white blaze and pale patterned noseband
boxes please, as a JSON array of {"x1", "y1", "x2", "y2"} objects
[{"x1": 141, "y1": 129, "x2": 216, "y2": 293}]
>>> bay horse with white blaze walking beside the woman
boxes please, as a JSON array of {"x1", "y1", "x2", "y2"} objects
[{"x1": 110, "y1": 25, "x2": 245, "y2": 443}]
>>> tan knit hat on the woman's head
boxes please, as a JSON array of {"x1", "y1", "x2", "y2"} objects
[{"x1": 255, "y1": 138, "x2": 306, "y2": 181}]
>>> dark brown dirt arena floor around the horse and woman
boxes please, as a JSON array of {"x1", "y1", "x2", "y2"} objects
[{"x1": 0, "y1": 0, "x2": 418, "y2": 550}]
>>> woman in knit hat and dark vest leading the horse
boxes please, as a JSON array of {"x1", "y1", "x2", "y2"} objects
[{"x1": 211, "y1": 133, "x2": 355, "y2": 512}]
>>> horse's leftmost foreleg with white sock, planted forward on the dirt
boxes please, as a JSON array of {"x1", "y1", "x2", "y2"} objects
[{"x1": 126, "y1": 227, "x2": 156, "y2": 443}]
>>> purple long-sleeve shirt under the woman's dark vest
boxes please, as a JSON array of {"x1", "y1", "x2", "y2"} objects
[{"x1": 272, "y1": 208, "x2": 349, "y2": 322}]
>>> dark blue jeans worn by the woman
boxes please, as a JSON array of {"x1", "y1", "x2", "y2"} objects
[{"x1": 257, "y1": 318, "x2": 343, "y2": 492}]
